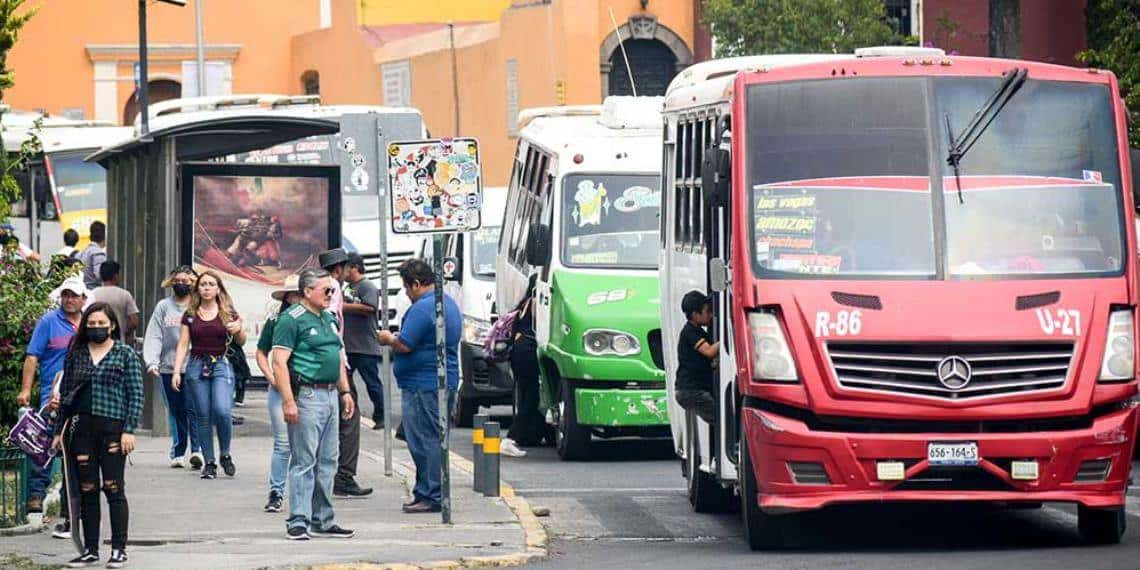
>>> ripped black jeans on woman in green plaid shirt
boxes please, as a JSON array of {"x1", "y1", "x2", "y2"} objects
[{"x1": 71, "y1": 414, "x2": 129, "y2": 552}]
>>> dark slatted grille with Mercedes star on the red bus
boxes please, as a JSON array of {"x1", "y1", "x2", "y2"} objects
[{"x1": 828, "y1": 342, "x2": 1073, "y2": 400}]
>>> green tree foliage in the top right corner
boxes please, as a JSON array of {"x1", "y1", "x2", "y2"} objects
[{"x1": 1077, "y1": 0, "x2": 1140, "y2": 148}]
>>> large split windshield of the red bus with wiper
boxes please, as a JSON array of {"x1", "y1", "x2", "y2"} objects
[{"x1": 746, "y1": 78, "x2": 1124, "y2": 279}]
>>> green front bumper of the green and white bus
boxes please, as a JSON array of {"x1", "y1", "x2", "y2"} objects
[{"x1": 575, "y1": 388, "x2": 669, "y2": 428}]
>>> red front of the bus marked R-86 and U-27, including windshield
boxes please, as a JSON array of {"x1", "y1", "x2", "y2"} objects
[{"x1": 665, "y1": 54, "x2": 1137, "y2": 548}]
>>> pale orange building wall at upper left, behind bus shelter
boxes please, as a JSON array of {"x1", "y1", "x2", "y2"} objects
[{"x1": 5, "y1": 0, "x2": 319, "y2": 117}]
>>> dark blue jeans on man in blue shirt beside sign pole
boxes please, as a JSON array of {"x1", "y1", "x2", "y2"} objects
[{"x1": 400, "y1": 389, "x2": 455, "y2": 505}]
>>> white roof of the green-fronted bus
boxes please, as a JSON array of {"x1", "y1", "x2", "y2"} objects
[{"x1": 519, "y1": 97, "x2": 663, "y2": 173}]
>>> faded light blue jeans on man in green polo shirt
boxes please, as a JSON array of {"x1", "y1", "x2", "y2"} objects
[{"x1": 285, "y1": 386, "x2": 341, "y2": 530}]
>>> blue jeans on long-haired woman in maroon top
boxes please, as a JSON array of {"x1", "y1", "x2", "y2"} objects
[{"x1": 186, "y1": 356, "x2": 234, "y2": 464}]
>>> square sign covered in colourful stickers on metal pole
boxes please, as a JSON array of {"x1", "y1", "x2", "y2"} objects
[{"x1": 388, "y1": 138, "x2": 483, "y2": 234}]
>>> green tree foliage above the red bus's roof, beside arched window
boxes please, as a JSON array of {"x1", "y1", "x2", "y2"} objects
[{"x1": 703, "y1": 0, "x2": 913, "y2": 56}]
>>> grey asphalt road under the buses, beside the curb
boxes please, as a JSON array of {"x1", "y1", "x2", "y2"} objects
[{"x1": 437, "y1": 408, "x2": 1140, "y2": 570}]
